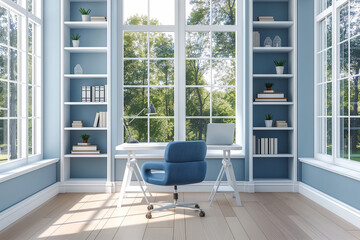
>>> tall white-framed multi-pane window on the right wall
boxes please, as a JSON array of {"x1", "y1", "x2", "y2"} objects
[{"x1": 315, "y1": 0, "x2": 360, "y2": 170}]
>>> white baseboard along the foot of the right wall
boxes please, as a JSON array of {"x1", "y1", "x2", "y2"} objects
[{"x1": 299, "y1": 183, "x2": 360, "y2": 228}]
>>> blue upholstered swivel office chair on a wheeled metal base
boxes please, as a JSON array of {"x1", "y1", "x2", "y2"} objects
[{"x1": 141, "y1": 141, "x2": 206, "y2": 219}]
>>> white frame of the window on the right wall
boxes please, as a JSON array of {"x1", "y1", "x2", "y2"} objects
[{"x1": 314, "y1": 0, "x2": 360, "y2": 171}]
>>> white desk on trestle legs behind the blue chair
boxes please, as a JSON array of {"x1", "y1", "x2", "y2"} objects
[{"x1": 116, "y1": 143, "x2": 242, "y2": 207}]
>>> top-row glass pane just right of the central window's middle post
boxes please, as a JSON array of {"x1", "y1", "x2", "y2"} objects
[{"x1": 186, "y1": 0, "x2": 210, "y2": 25}]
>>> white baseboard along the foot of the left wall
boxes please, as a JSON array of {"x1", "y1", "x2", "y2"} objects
[{"x1": 0, "y1": 183, "x2": 59, "y2": 231}]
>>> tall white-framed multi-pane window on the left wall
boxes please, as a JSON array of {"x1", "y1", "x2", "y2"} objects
[{"x1": 0, "y1": 0, "x2": 42, "y2": 163}]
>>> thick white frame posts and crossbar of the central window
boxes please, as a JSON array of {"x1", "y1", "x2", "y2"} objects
[{"x1": 118, "y1": 0, "x2": 245, "y2": 148}]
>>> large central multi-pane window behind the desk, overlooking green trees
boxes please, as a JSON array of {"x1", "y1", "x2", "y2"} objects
[{"x1": 121, "y1": 0, "x2": 243, "y2": 143}]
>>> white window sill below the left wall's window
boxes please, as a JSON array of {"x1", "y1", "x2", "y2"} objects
[{"x1": 0, "y1": 158, "x2": 59, "y2": 183}]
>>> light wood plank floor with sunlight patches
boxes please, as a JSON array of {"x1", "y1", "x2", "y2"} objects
[{"x1": 0, "y1": 193, "x2": 360, "y2": 240}]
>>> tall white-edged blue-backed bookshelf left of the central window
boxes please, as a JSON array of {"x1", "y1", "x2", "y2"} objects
[{"x1": 60, "y1": 0, "x2": 113, "y2": 192}]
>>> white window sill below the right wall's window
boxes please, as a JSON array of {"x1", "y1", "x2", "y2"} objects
[{"x1": 299, "y1": 158, "x2": 360, "y2": 181}]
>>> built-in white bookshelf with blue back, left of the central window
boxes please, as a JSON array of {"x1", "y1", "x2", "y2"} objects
[{"x1": 60, "y1": 0, "x2": 112, "y2": 192}]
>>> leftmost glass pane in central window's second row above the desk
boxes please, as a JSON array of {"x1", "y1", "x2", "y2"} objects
[{"x1": 124, "y1": 88, "x2": 148, "y2": 116}]
